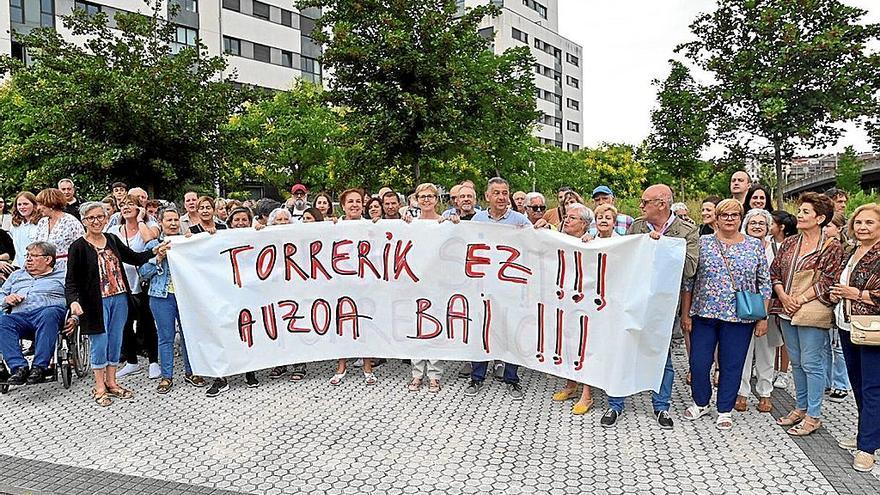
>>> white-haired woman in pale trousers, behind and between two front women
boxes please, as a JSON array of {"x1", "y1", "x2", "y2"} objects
[{"x1": 734, "y1": 208, "x2": 782, "y2": 412}]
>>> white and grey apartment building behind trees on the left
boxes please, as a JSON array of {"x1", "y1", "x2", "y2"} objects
[{"x1": 0, "y1": 0, "x2": 323, "y2": 90}]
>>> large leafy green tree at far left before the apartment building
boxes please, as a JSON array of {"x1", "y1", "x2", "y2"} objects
[{"x1": 0, "y1": 0, "x2": 244, "y2": 197}]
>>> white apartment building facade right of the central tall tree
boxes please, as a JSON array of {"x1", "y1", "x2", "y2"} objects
[{"x1": 458, "y1": 0, "x2": 584, "y2": 151}]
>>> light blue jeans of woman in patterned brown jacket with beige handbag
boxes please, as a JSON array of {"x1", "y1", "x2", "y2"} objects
[{"x1": 779, "y1": 318, "x2": 829, "y2": 418}]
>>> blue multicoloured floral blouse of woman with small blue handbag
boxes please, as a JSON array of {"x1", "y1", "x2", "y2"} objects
[{"x1": 685, "y1": 234, "x2": 772, "y2": 323}]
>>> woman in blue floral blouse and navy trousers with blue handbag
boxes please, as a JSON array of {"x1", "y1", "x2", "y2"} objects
[{"x1": 681, "y1": 199, "x2": 771, "y2": 430}]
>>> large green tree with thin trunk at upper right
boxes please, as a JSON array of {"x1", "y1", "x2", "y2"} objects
[{"x1": 678, "y1": 0, "x2": 880, "y2": 209}]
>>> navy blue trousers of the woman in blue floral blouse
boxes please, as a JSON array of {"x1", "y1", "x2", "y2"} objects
[{"x1": 690, "y1": 316, "x2": 755, "y2": 413}]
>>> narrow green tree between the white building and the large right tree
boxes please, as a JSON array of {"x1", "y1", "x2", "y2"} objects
[{"x1": 647, "y1": 60, "x2": 711, "y2": 196}]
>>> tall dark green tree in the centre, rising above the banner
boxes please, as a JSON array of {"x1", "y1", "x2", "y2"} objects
[{"x1": 297, "y1": 0, "x2": 538, "y2": 186}]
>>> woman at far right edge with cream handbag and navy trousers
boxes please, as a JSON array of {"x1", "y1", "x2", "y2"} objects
[{"x1": 831, "y1": 203, "x2": 880, "y2": 472}]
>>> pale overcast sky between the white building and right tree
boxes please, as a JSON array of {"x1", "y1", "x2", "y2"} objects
[{"x1": 559, "y1": 0, "x2": 880, "y2": 155}]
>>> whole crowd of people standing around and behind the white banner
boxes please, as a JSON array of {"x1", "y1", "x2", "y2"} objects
[{"x1": 0, "y1": 171, "x2": 880, "y2": 471}]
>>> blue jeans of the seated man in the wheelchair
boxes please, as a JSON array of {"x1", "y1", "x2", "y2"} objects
[{"x1": 0, "y1": 306, "x2": 65, "y2": 372}]
